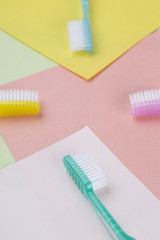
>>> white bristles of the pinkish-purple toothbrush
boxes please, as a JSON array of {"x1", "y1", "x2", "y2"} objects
[{"x1": 129, "y1": 89, "x2": 160, "y2": 105}]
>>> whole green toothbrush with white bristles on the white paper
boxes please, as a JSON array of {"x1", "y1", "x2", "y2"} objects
[{"x1": 63, "y1": 154, "x2": 135, "y2": 240}]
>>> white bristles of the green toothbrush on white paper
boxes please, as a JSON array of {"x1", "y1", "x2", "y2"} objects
[{"x1": 73, "y1": 153, "x2": 107, "y2": 190}]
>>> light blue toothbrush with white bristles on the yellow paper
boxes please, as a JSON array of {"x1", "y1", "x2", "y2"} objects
[{"x1": 68, "y1": 0, "x2": 92, "y2": 52}]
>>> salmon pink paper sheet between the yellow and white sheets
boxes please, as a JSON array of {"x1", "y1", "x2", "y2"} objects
[{"x1": 0, "y1": 32, "x2": 160, "y2": 199}]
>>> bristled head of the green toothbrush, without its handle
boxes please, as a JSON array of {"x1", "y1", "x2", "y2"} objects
[{"x1": 63, "y1": 153, "x2": 107, "y2": 196}]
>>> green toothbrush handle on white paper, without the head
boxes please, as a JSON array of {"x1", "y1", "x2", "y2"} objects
[{"x1": 88, "y1": 191, "x2": 135, "y2": 240}]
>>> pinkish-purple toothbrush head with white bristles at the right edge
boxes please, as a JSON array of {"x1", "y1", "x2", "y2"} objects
[{"x1": 129, "y1": 89, "x2": 160, "y2": 116}]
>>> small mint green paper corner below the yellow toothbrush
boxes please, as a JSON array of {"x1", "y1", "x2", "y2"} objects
[{"x1": 0, "y1": 135, "x2": 15, "y2": 169}]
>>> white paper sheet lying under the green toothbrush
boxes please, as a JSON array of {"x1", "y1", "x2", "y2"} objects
[{"x1": 0, "y1": 127, "x2": 160, "y2": 240}]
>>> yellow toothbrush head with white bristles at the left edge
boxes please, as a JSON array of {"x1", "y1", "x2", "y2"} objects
[{"x1": 0, "y1": 90, "x2": 40, "y2": 117}]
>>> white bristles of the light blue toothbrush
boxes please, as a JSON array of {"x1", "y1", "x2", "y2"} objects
[{"x1": 68, "y1": 21, "x2": 86, "y2": 51}]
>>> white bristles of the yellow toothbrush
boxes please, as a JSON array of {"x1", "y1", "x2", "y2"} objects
[{"x1": 0, "y1": 89, "x2": 38, "y2": 102}]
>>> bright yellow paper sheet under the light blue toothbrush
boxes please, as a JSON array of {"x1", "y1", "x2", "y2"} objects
[{"x1": 0, "y1": 0, "x2": 160, "y2": 79}]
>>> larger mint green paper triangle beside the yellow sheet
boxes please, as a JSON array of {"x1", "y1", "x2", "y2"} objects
[{"x1": 0, "y1": 30, "x2": 57, "y2": 85}]
